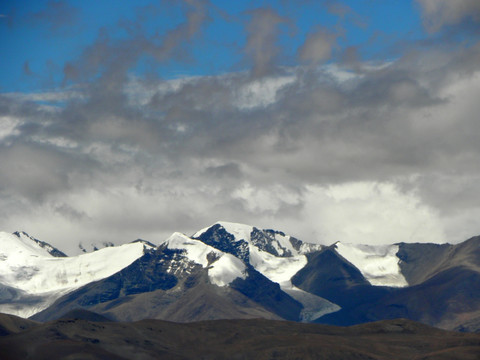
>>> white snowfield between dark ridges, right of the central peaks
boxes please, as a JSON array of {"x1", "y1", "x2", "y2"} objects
[{"x1": 335, "y1": 242, "x2": 408, "y2": 287}]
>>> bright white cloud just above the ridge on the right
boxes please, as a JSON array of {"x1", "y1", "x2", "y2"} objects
[{"x1": 303, "y1": 182, "x2": 446, "y2": 244}]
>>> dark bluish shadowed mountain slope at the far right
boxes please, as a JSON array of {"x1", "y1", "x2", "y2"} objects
[{"x1": 318, "y1": 267, "x2": 480, "y2": 331}]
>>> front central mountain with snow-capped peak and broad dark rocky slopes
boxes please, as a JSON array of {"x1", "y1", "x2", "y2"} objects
[{"x1": 33, "y1": 233, "x2": 302, "y2": 321}]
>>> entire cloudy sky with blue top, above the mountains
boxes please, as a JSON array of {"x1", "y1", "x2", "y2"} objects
[{"x1": 0, "y1": 0, "x2": 480, "y2": 254}]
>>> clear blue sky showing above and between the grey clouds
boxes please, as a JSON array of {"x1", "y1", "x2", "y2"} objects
[{"x1": 0, "y1": 0, "x2": 426, "y2": 92}]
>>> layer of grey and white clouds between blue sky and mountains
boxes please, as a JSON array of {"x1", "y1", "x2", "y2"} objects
[{"x1": 0, "y1": 1, "x2": 480, "y2": 253}]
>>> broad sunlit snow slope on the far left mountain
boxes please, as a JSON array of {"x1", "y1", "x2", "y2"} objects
[{"x1": 0, "y1": 232, "x2": 154, "y2": 317}]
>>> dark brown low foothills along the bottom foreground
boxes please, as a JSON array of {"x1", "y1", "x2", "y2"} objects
[{"x1": 0, "y1": 319, "x2": 480, "y2": 360}]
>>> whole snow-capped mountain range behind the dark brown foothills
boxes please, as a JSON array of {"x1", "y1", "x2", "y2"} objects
[{"x1": 0, "y1": 222, "x2": 480, "y2": 332}]
